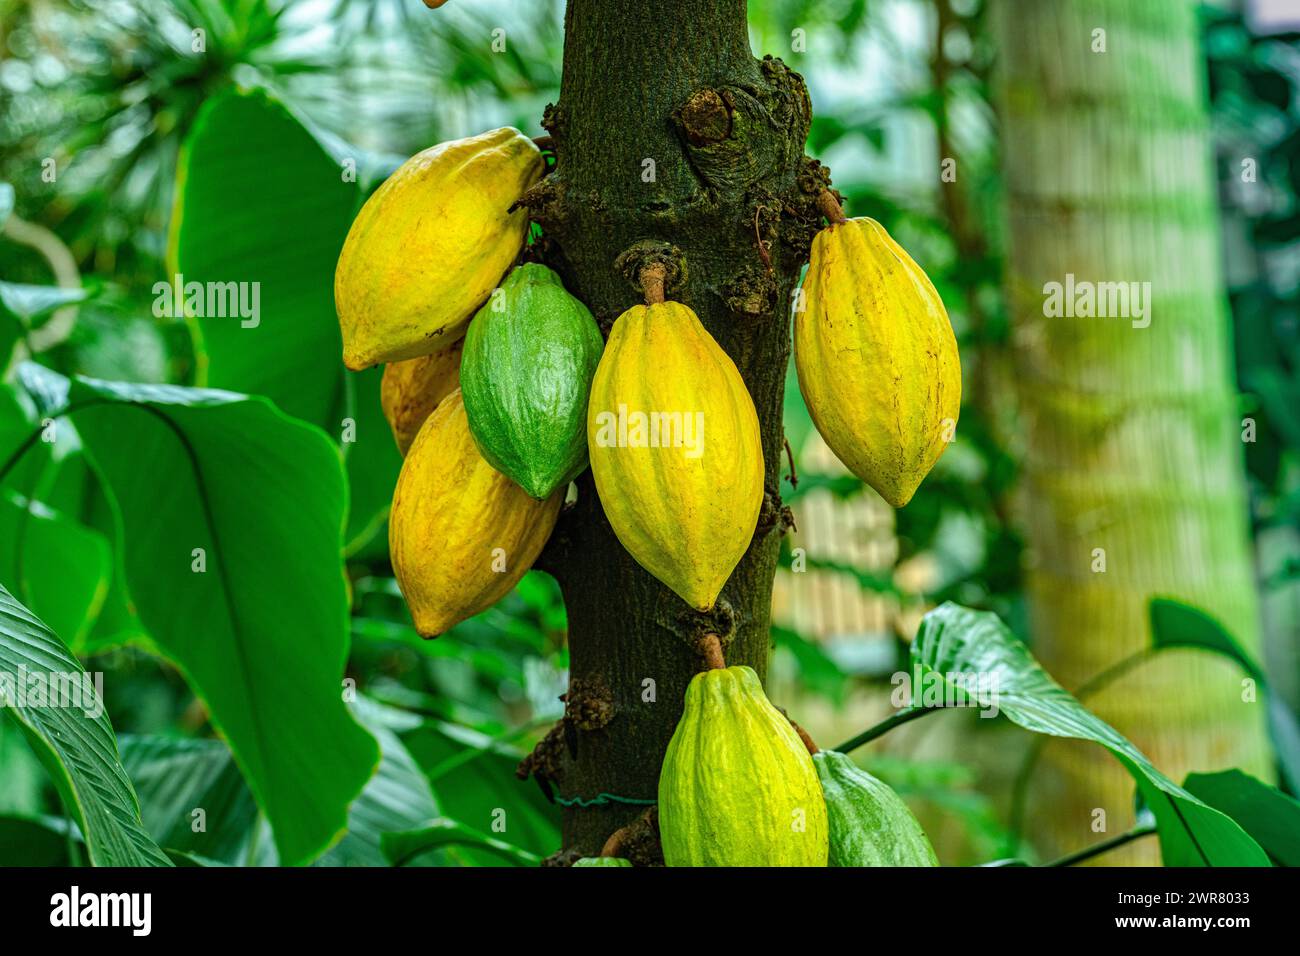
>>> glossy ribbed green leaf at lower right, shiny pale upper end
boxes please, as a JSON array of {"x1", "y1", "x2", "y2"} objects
[{"x1": 911, "y1": 602, "x2": 1269, "y2": 866}]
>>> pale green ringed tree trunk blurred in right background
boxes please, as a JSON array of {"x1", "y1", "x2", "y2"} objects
[{"x1": 995, "y1": 0, "x2": 1271, "y2": 864}]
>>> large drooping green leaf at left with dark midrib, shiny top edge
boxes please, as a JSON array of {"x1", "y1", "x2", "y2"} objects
[{"x1": 22, "y1": 364, "x2": 378, "y2": 864}]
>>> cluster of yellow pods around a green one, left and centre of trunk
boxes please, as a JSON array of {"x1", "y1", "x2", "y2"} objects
[{"x1": 334, "y1": 127, "x2": 764, "y2": 636}]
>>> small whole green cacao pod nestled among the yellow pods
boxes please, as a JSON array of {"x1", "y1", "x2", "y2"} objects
[{"x1": 460, "y1": 263, "x2": 605, "y2": 498}]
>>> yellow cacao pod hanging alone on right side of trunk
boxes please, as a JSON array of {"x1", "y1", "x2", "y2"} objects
[{"x1": 794, "y1": 219, "x2": 962, "y2": 507}]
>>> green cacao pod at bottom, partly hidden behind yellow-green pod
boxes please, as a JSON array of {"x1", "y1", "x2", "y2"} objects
[{"x1": 813, "y1": 750, "x2": 939, "y2": 866}]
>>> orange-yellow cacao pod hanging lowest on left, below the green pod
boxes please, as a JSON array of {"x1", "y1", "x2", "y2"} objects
[{"x1": 389, "y1": 389, "x2": 564, "y2": 637}]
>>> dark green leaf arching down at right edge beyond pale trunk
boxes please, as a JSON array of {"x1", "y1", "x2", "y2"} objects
[{"x1": 1149, "y1": 597, "x2": 1300, "y2": 793}]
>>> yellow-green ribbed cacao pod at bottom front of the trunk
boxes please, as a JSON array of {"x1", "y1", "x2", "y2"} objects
[{"x1": 659, "y1": 667, "x2": 827, "y2": 866}]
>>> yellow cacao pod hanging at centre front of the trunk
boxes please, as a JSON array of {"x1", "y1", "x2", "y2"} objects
[{"x1": 586, "y1": 302, "x2": 763, "y2": 610}]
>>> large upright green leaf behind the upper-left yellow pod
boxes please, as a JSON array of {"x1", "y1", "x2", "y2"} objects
[{"x1": 169, "y1": 90, "x2": 402, "y2": 548}]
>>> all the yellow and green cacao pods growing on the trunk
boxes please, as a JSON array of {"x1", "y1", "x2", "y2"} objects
[{"x1": 334, "y1": 127, "x2": 961, "y2": 866}]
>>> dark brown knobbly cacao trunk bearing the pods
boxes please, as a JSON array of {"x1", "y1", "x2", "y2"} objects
[{"x1": 525, "y1": 0, "x2": 824, "y2": 855}]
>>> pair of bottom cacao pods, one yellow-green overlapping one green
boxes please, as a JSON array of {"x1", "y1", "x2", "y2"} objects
[{"x1": 659, "y1": 658, "x2": 937, "y2": 866}]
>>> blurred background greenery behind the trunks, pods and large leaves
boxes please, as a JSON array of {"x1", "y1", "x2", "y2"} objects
[{"x1": 0, "y1": 0, "x2": 1300, "y2": 864}]
